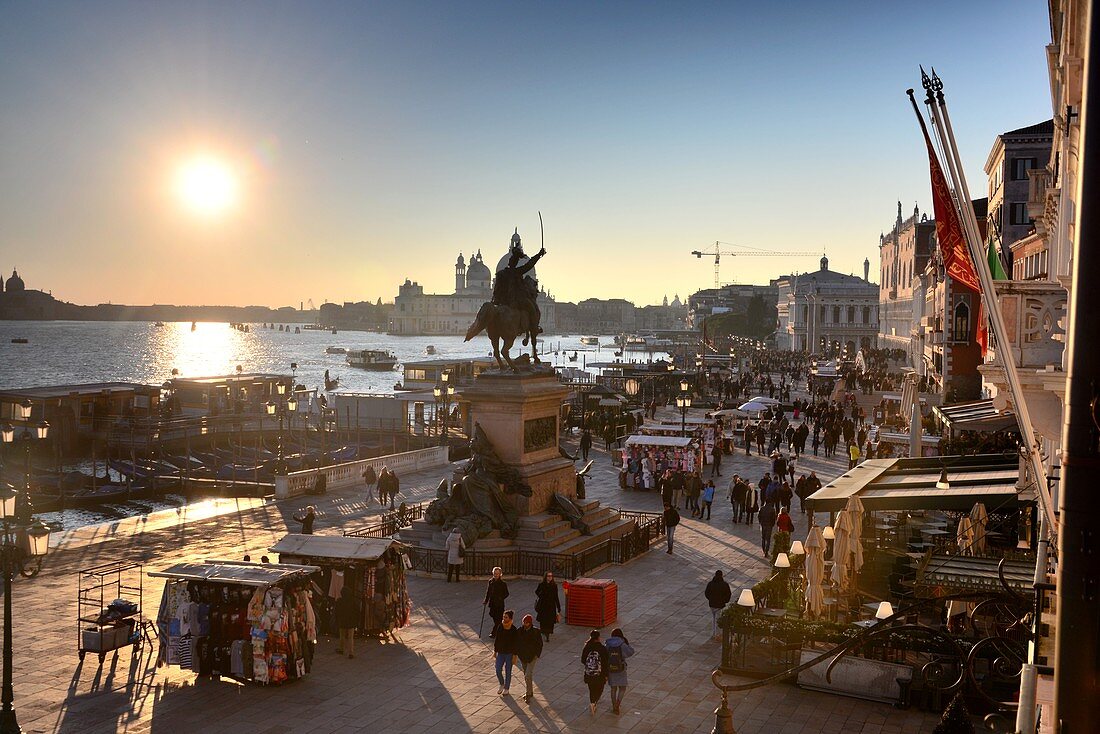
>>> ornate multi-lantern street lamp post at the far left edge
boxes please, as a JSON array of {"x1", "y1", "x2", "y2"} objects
[{"x1": 0, "y1": 424, "x2": 50, "y2": 734}]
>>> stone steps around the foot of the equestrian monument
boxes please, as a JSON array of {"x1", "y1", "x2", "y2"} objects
[{"x1": 398, "y1": 500, "x2": 635, "y2": 555}]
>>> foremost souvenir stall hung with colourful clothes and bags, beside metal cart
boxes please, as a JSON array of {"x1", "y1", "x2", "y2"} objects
[{"x1": 150, "y1": 560, "x2": 320, "y2": 684}]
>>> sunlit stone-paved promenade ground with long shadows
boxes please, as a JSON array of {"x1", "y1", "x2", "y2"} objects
[{"x1": 13, "y1": 404, "x2": 936, "y2": 734}]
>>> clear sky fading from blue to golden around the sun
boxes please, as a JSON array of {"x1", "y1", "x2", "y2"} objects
[{"x1": 0, "y1": 0, "x2": 1051, "y2": 306}]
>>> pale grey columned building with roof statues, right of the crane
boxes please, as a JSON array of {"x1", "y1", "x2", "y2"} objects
[{"x1": 776, "y1": 256, "x2": 879, "y2": 358}]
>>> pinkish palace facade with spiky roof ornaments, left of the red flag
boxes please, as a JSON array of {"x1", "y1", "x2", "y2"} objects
[{"x1": 879, "y1": 201, "x2": 936, "y2": 366}]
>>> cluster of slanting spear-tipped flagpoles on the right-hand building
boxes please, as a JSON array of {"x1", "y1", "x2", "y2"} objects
[{"x1": 906, "y1": 83, "x2": 1058, "y2": 533}]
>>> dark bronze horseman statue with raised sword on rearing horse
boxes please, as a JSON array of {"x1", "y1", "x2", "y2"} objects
[{"x1": 465, "y1": 227, "x2": 547, "y2": 372}]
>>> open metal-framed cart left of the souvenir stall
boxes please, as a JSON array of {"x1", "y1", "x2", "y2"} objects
[{"x1": 77, "y1": 561, "x2": 156, "y2": 662}]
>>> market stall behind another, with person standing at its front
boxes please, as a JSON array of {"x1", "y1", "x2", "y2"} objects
[{"x1": 271, "y1": 534, "x2": 413, "y2": 635}]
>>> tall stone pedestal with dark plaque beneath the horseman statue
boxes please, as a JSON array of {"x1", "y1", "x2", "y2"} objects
[{"x1": 462, "y1": 370, "x2": 576, "y2": 517}]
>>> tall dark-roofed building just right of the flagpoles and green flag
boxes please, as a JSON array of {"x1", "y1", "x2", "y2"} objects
[{"x1": 986, "y1": 119, "x2": 1054, "y2": 280}]
